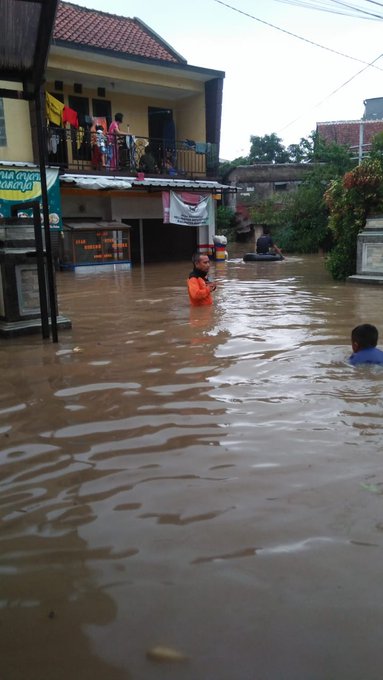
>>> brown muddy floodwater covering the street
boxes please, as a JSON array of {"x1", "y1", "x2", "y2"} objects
[{"x1": 0, "y1": 250, "x2": 383, "y2": 680}]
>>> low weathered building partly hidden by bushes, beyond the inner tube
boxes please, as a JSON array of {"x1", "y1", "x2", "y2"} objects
[{"x1": 225, "y1": 163, "x2": 312, "y2": 239}]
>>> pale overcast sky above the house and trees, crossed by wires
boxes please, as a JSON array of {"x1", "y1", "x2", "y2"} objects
[{"x1": 70, "y1": 0, "x2": 383, "y2": 160}]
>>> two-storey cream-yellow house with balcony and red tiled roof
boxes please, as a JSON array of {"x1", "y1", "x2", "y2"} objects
[{"x1": 0, "y1": 2, "x2": 228, "y2": 262}]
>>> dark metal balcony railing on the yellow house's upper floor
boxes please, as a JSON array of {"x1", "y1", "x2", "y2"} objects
[{"x1": 47, "y1": 127, "x2": 218, "y2": 179}]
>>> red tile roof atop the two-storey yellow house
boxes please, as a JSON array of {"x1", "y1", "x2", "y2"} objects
[{"x1": 53, "y1": 2, "x2": 186, "y2": 64}]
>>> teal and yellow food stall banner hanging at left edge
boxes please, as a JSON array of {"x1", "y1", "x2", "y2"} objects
[{"x1": 0, "y1": 166, "x2": 62, "y2": 230}]
